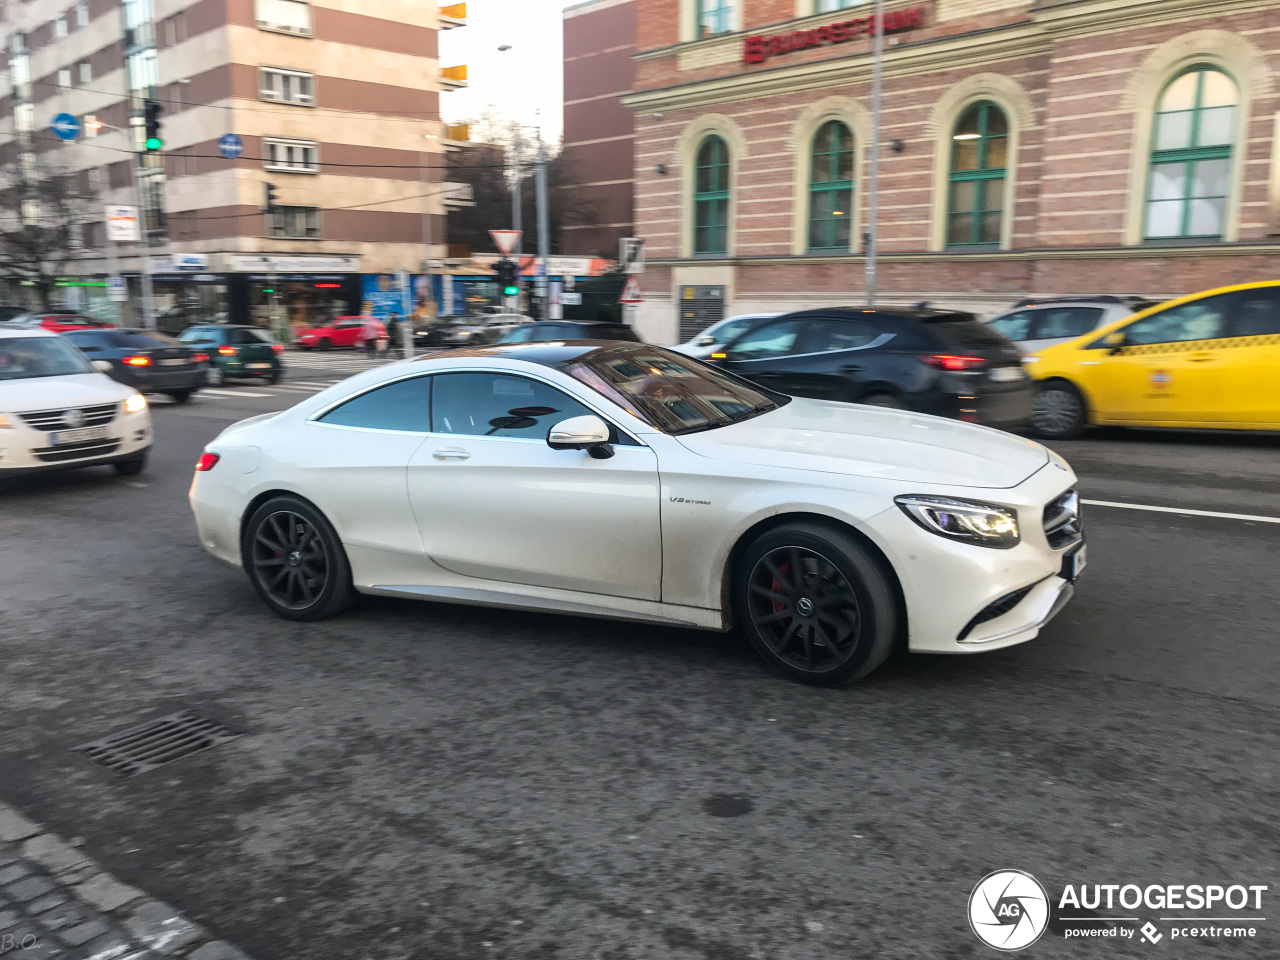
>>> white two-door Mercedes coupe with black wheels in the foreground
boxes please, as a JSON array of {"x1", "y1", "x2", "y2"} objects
[{"x1": 191, "y1": 340, "x2": 1084, "y2": 685}]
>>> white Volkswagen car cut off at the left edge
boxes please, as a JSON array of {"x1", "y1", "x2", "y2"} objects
[{"x1": 0, "y1": 326, "x2": 152, "y2": 477}]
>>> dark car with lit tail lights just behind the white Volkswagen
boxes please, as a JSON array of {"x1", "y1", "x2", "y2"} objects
[{"x1": 63, "y1": 330, "x2": 209, "y2": 403}]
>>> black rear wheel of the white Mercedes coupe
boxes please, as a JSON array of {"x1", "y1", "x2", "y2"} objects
[{"x1": 241, "y1": 497, "x2": 356, "y2": 621}]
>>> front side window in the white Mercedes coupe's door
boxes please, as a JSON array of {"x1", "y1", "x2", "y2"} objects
[{"x1": 431, "y1": 374, "x2": 594, "y2": 440}]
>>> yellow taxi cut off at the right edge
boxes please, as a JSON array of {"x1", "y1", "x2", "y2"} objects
[{"x1": 1024, "y1": 280, "x2": 1280, "y2": 439}]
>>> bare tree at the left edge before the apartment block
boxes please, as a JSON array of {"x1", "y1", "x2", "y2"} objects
[{"x1": 0, "y1": 152, "x2": 101, "y2": 307}]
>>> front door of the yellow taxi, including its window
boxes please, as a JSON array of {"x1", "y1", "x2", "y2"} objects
[{"x1": 1092, "y1": 293, "x2": 1234, "y2": 425}]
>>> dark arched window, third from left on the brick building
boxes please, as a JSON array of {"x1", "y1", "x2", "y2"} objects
[{"x1": 947, "y1": 100, "x2": 1009, "y2": 246}]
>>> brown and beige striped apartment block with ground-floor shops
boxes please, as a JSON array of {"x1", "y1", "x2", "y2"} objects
[{"x1": 0, "y1": 0, "x2": 466, "y2": 323}]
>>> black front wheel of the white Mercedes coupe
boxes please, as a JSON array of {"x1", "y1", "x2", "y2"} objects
[{"x1": 733, "y1": 524, "x2": 897, "y2": 686}]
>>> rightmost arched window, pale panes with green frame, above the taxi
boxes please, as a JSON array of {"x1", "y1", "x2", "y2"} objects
[{"x1": 1144, "y1": 67, "x2": 1239, "y2": 239}]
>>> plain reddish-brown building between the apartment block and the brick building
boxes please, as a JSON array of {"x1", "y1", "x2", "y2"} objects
[{"x1": 561, "y1": 0, "x2": 639, "y2": 257}]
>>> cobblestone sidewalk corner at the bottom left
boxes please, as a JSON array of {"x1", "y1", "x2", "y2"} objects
[{"x1": 0, "y1": 804, "x2": 250, "y2": 960}]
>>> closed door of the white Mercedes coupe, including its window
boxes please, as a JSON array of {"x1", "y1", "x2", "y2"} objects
[{"x1": 408, "y1": 371, "x2": 662, "y2": 600}]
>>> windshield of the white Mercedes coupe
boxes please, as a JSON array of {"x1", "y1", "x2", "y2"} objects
[{"x1": 564, "y1": 344, "x2": 790, "y2": 434}]
